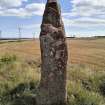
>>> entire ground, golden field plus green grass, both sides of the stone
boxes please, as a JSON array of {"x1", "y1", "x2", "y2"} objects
[{"x1": 0, "y1": 39, "x2": 105, "y2": 105}]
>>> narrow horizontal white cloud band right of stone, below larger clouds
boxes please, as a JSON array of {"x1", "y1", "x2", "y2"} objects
[{"x1": 63, "y1": 17, "x2": 105, "y2": 29}]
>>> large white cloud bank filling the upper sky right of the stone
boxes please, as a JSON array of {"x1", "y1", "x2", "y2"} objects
[{"x1": 62, "y1": 0, "x2": 105, "y2": 29}]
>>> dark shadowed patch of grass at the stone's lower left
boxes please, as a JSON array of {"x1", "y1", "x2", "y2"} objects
[{"x1": 0, "y1": 82, "x2": 37, "y2": 105}]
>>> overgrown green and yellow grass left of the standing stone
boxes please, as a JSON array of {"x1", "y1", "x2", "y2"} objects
[{"x1": 0, "y1": 55, "x2": 40, "y2": 105}]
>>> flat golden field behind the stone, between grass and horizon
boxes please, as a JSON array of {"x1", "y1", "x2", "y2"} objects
[{"x1": 0, "y1": 39, "x2": 105, "y2": 69}]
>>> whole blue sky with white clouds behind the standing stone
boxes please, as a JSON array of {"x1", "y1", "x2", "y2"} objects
[{"x1": 0, "y1": 0, "x2": 105, "y2": 38}]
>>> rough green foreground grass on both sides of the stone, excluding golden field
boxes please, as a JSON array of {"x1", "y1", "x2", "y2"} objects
[{"x1": 0, "y1": 54, "x2": 105, "y2": 105}]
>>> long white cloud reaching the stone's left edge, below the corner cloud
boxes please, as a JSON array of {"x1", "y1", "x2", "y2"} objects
[{"x1": 0, "y1": 3, "x2": 45, "y2": 17}]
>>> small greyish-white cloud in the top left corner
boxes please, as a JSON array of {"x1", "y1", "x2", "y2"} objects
[{"x1": 0, "y1": 0, "x2": 27, "y2": 8}]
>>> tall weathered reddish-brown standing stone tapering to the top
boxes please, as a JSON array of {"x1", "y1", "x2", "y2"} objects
[{"x1": 36, "y1": 0, "x2": 68, "y2": 105}]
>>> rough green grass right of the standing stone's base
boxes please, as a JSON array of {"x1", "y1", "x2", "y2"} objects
[{"x1": 67, "y1": 65, "x2": 105, "y2": 105}]
